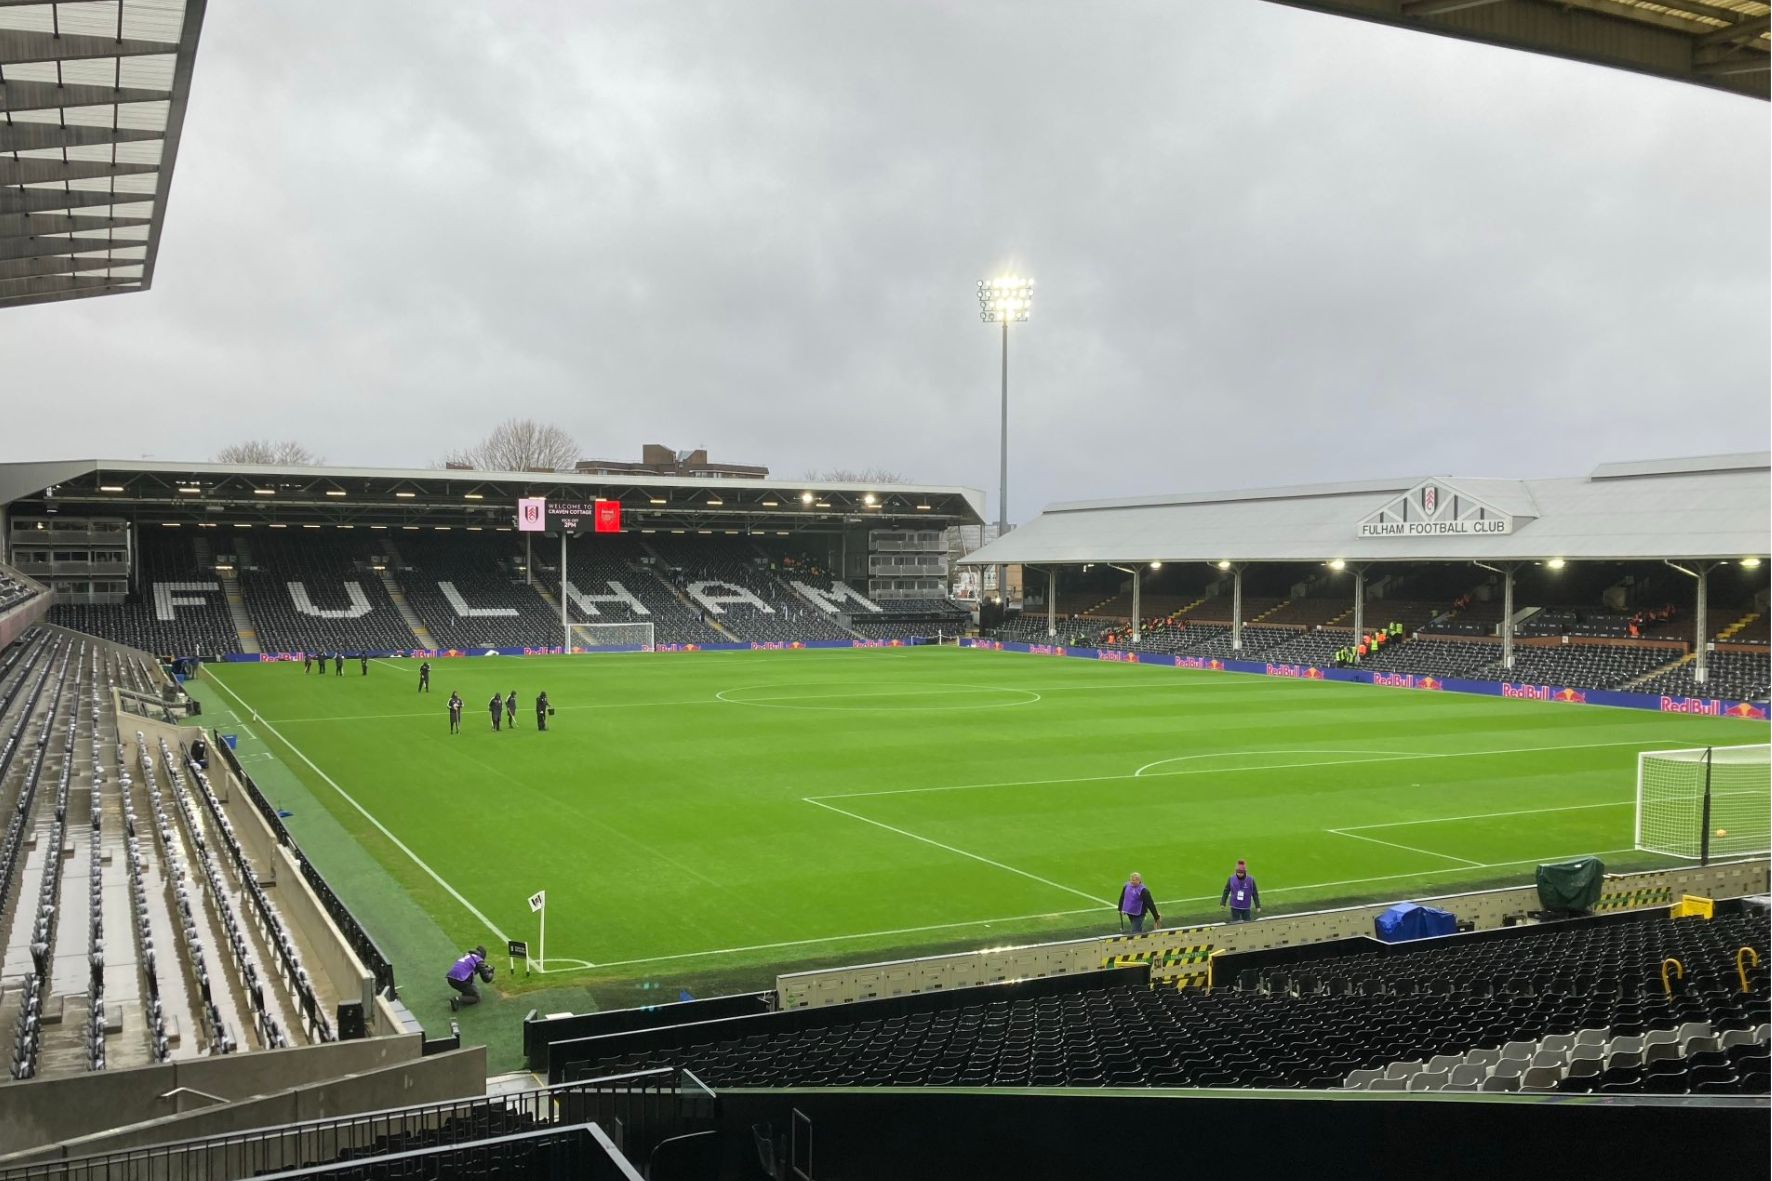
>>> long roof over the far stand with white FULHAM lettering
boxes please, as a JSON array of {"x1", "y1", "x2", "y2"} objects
[{"x1": 0, "y1": 453, "x2": 983, "y2": 530}]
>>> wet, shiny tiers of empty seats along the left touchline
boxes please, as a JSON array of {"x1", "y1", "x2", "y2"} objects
[{"x1": 0, "y1": 628, "x2": 335, "y2": 1078}]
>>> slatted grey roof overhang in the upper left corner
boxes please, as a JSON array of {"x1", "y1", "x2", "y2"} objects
[{"x1": 0, "y1": 0, "x2": 207, "y2": 309}]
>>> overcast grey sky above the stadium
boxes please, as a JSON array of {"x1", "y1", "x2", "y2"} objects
[{"x1": 0, "y1": 0, "x2": 1772, "y2": 520}]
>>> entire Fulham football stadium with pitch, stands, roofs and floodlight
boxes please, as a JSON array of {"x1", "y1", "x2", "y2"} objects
[{"x1": 0, "y1": 0, "x2": 1772, "y2": 1181}]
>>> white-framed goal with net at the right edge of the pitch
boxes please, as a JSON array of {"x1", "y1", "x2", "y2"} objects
[{"x1": 1637, "y1": 745, "x2": 1772, "y2": 862}]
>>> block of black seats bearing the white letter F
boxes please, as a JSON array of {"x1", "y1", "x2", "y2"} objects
[{"x1": 50, "y1": 528, "x2": 239, "y2": 656}]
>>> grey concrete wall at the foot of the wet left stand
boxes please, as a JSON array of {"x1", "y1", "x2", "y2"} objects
[{"x1": 0, "y1": 1034, "x2": 425, "y2": 1158}]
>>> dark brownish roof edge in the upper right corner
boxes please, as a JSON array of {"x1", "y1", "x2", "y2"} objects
[{"x1": 1271, "y1": 0, "x2": 1772, "y2": 99}]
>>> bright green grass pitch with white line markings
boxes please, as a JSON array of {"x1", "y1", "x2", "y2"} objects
[{"x1": 198, "y1": 649, "x2": 1767, "y2": 991}]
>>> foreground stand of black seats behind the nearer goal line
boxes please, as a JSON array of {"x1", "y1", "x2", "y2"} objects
[{"x1": 555, "y1": 911, "x2": 1768, "y2": 1094}]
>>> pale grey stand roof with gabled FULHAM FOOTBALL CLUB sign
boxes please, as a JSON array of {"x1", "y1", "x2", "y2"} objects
[{"x1": 962, "y1": 452, "x2": 1772, "y2": 566}]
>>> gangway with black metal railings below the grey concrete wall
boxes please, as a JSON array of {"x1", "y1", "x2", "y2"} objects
[{"x1": 0, "y1": 1066, "x2": 719, "y2": 1181}]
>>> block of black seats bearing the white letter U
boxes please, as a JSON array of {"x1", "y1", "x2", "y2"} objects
[{"x1": 236, "y1": 530, "x2": 418, "y2": 654}]
